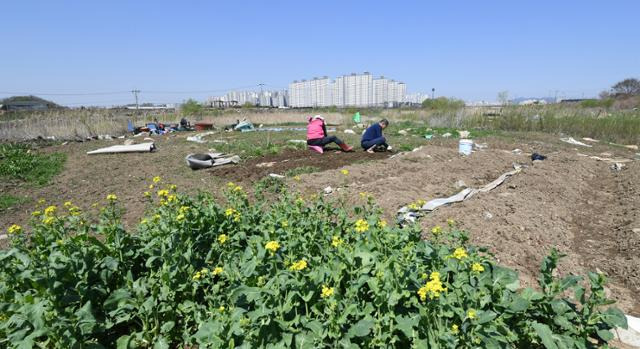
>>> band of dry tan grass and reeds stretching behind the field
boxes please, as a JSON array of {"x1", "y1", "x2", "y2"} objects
[{"x1": 0, "y1": 104, "x2": 640, "y2": 144}]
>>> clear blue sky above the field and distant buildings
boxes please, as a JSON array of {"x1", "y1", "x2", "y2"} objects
[{"x1": 0, "y1": 0, "x2": 640, "y2": 105}]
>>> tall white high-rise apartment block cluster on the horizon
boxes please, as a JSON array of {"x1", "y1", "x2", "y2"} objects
[{"x1": 289, "y1": 72, "x2": 407, "y2": 107}]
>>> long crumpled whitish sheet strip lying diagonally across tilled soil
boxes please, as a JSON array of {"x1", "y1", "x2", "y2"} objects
[{"x1": 397, "y1": 164, "x2": 522, "y2": 225}]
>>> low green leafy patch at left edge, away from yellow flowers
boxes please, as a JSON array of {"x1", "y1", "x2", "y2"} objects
[{"x1": 0, "y1": 144, "x2": 66, "y2": 185}]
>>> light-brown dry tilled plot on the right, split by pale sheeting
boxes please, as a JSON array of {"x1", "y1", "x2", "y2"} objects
[{"x1": 297, "y1": 140, "x2": 640, "y2": 316}]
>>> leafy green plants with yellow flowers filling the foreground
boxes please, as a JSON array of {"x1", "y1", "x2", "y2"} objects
[{"x1": 0, "y1": 179, "x2": 626, "y2": 348}]
